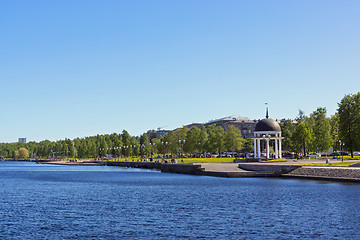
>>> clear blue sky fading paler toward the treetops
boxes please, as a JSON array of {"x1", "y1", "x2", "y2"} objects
[{"x1": 0, "y1": 0, "x2": 360, "y2": 142}]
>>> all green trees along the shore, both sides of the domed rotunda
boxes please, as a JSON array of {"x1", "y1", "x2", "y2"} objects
[{"x1": 0, "y1": 93, "x2": 360, "y2": 159}]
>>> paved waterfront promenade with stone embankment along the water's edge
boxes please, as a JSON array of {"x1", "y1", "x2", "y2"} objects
[{"x1": 41, "y1": 159, "x2": 360, "y2": 183}]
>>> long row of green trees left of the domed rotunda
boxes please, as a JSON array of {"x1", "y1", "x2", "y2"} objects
[{"x1": 0, "y1": 125, "x2": 251, "y2": 159}]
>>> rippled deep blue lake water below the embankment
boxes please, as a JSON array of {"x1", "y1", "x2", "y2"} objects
[{"x1": 0, "y1": 162, "x2": 360, "y2": 239}]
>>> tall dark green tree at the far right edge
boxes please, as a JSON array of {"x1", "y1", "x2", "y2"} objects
[{"x1": 338, "y1": 92, "x2": 360, "y2": 157}]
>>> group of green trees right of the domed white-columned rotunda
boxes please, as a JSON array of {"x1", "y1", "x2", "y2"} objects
[{"x1": 281, "y1": 93, "x2": 360, "y2": 157}]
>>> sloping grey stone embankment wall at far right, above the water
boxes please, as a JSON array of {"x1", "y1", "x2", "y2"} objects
[{"x1": 282, "y1": 166, "x2": 360, "y2": 182}]
